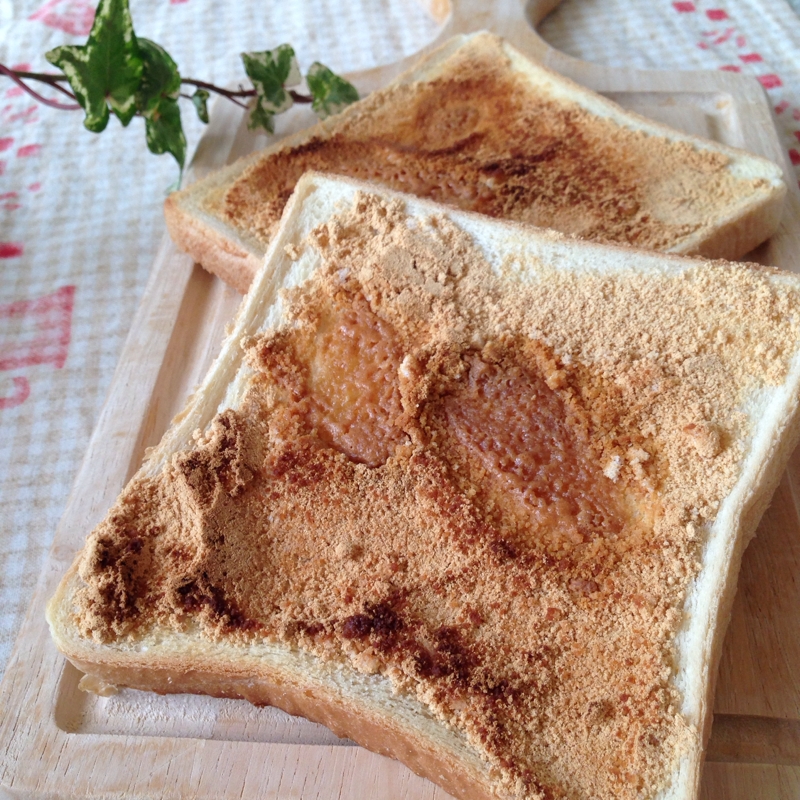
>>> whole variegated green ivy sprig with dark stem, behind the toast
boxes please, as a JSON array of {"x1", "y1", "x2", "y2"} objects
[{"x1": 0, "y1": 0, "x2": 358, "y2": 171}]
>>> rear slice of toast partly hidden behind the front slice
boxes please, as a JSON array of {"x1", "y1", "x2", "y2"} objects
[{"x1": 165, "y1": 33, "x2": 786, "y2": 292}]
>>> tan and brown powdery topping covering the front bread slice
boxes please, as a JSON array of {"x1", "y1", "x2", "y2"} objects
[{"x1": 76, "y1": 195, "x2": 798, "y2": 798}]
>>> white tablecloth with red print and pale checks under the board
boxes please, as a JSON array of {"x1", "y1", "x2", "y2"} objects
[{"x1": 0, "y1": 0, "x2": 800, "y2": 692}]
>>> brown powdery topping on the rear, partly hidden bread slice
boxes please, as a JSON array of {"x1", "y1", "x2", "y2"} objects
[{"x1": 220, "y1": 33, "x2": 757, "y2": 250}]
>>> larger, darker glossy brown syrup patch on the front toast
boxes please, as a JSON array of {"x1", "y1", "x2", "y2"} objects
[{"x1": 442, "y1": 353, "x2": 623, "y2": 553}]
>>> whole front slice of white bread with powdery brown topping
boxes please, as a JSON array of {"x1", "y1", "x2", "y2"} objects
[{"x1": 48, "y1": 174, "x2": 800, "y2": 798}]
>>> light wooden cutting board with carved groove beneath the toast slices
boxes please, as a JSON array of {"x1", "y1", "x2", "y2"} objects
[{"x1": 0, "y1": 0, "x2": 800, "y2": 800}]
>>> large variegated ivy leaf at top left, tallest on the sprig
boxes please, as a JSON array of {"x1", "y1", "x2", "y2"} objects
[{"x1": 45, "y1": 0, "x2": 142, "y2": 133}]
